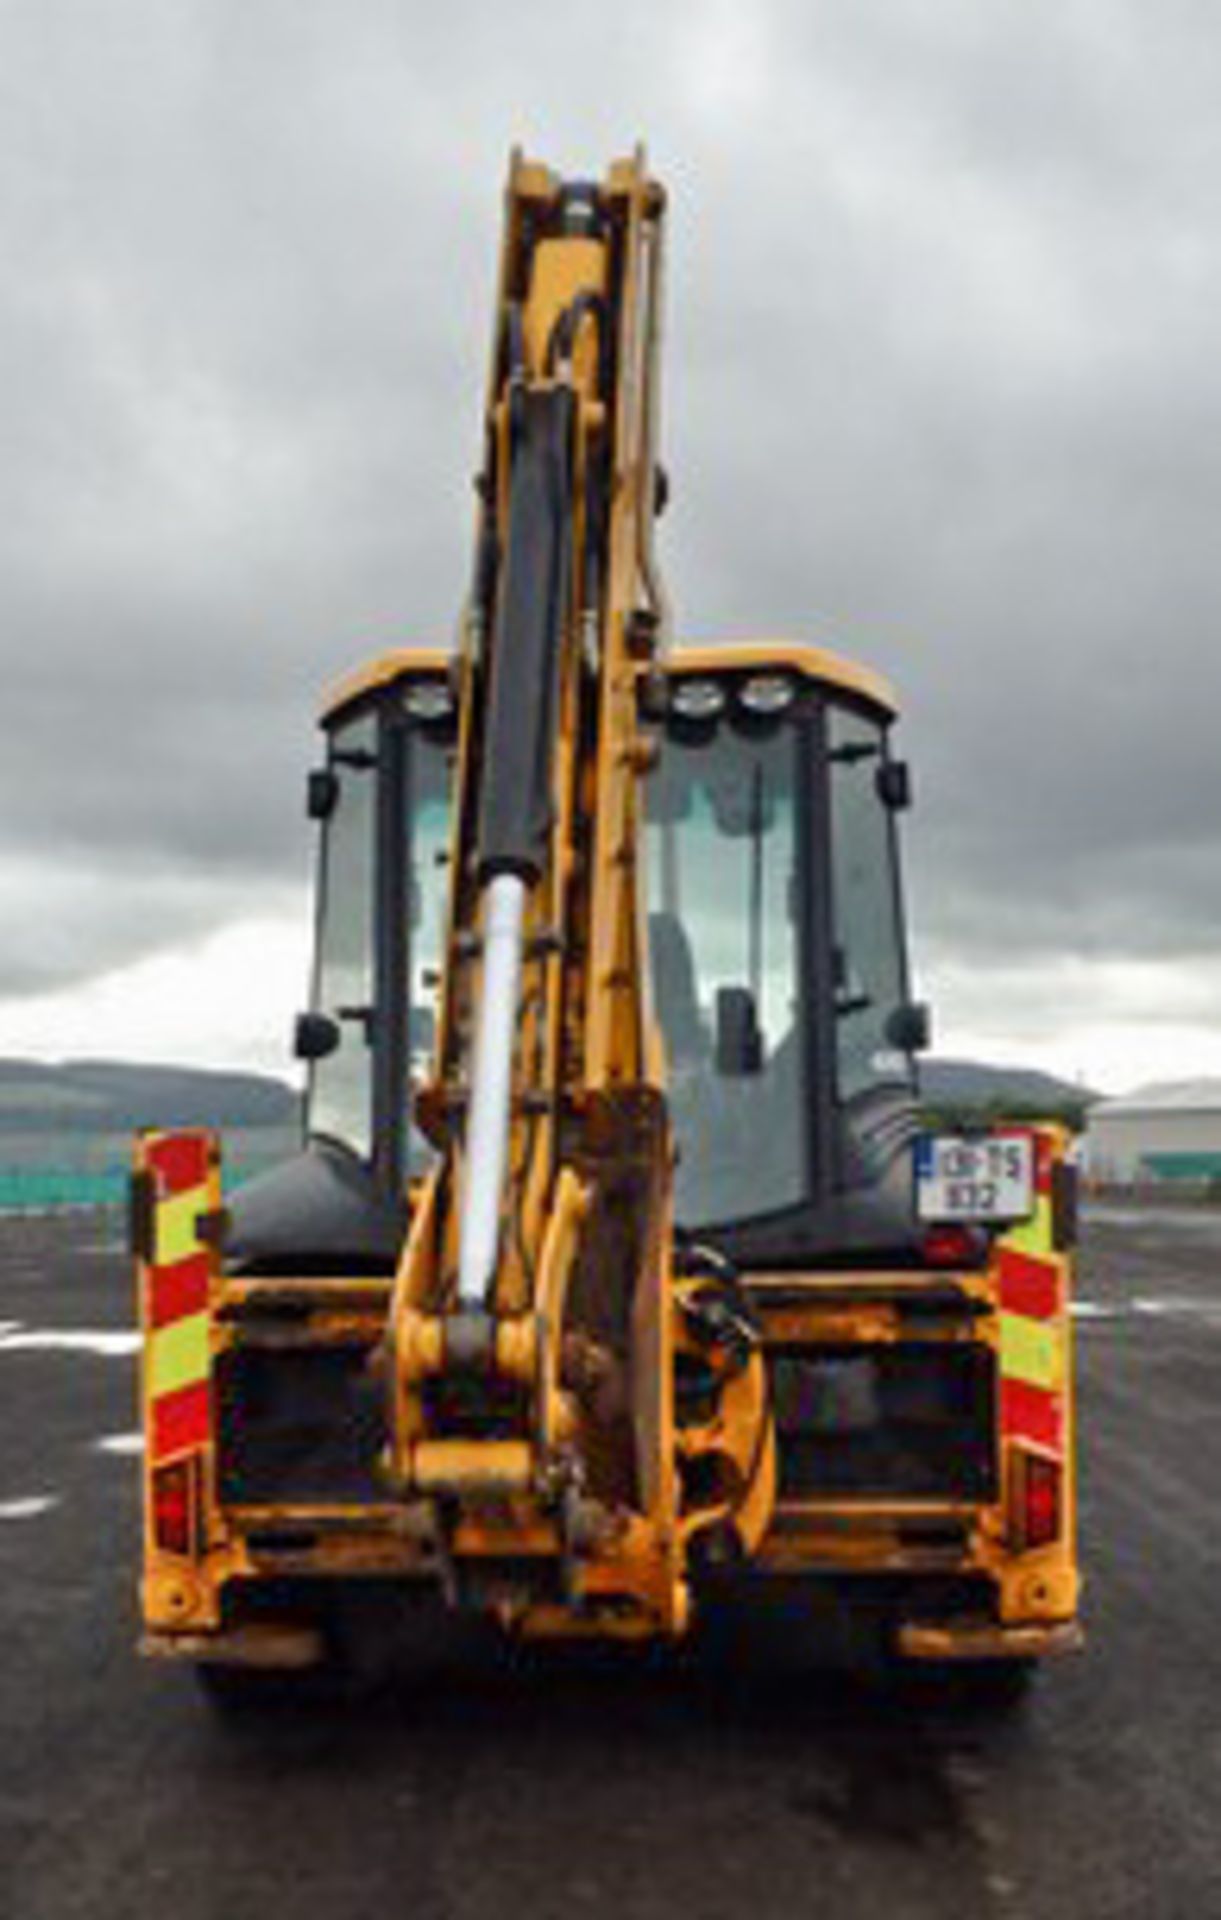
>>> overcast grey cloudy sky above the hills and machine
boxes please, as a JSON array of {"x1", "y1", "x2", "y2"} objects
[{"x1": 0, "y1": 0, "x2": 1221, "y2": 1087}]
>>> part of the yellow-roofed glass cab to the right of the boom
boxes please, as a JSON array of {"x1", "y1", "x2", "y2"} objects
[{"x1": 643, "y1": 645, "x2": 923, "y2": 1267}]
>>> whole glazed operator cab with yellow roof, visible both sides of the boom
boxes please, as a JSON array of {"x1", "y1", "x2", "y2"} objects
[{"x1": 230, "y1": 645, "x2": 922, "y2": 1271}]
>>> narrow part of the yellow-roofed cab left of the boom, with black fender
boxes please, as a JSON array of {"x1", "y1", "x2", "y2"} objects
[{"x1": 228, "y1": 649, "x2": 457, "y2": 1273}]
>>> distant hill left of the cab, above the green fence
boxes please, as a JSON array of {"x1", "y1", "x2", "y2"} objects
[{"x1": 0, "y1": 1060, "x2": 299, "y2": 1133}]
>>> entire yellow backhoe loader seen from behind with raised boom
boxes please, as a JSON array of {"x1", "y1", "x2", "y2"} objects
[{"x1": 134, "y1": 156, "x2": 1077, "y2": 1697}]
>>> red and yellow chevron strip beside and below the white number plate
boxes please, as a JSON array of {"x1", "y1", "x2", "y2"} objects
[{"x1": 996, "y1": 1127, "x2": 1067, "y2": 1457}]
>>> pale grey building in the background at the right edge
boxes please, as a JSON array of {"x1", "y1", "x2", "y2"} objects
[{"x1": 1085, "y1": 1079, "x2": 1221, "y2": 1187}]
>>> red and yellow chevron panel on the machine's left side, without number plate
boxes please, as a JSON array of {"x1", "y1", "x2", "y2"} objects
[{"x1": 136, "y1": 1131, "x2": 221, "y2": 1467}]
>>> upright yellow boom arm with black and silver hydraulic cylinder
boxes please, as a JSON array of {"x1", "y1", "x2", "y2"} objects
[{"x1": 390, "y1": 154, "x2": 678, "y2": 1611}]
